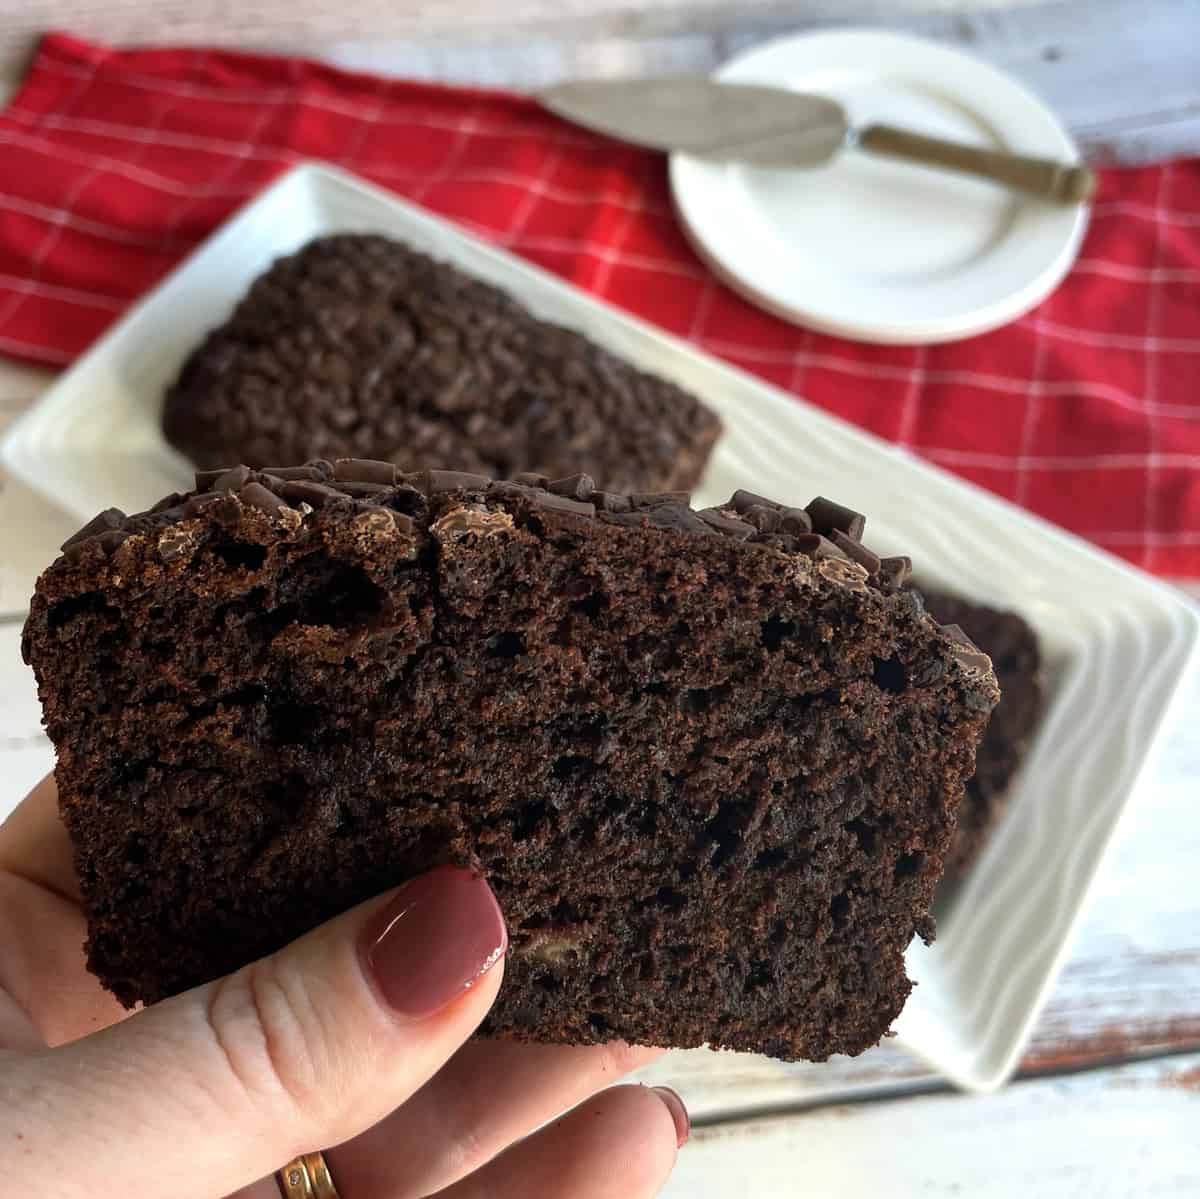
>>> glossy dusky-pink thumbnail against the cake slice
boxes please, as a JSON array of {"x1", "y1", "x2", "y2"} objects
[{"x1": 365, "y1": 867, "x2": 509, "y2": 1020}]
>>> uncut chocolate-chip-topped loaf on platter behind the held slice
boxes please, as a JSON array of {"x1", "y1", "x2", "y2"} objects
[{"x1": 163, "y1": 234, "x2": 720, "y2": 492}]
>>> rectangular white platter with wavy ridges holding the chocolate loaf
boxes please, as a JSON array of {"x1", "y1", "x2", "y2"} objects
[{"x1": 2, "y1": 166, "x2": 1200, "y2": 1090}]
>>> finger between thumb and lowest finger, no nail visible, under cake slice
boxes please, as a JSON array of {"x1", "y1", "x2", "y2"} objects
[{"x1": 325, "y1": 1041, "x2": 662, "y2": 1199}]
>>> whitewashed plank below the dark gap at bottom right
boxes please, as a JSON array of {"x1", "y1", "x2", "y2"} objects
[{"x1": 662, "y1": 1054, "x2": 1200, "y2": 1199}]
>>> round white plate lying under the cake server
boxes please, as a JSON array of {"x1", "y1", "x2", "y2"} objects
[{"x1": 671, "y1": 31, "x2": 1087, "y2": 344}]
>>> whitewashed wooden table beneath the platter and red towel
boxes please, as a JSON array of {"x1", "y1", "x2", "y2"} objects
[{"x1": 0, "y1": 0, "x2": 1200, "y2": 1199}]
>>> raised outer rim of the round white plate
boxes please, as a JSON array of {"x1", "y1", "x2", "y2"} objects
[{"x1": 670, "y1": 30, "x2": 1087, "y2": 344}]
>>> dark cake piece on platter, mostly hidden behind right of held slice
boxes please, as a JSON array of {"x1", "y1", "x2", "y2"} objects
[{"x1": 920, "y1": 587, "x2": 1044, "y2": 879}]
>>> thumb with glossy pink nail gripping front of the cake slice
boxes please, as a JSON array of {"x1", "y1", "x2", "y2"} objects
[{"x1": 0, "y1": 867, "x2": 506, "y2": 1199}]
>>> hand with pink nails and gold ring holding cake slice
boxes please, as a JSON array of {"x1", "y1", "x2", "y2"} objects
[{"x1": 0, "y1": 779, "x2": 688, "y2": 1199}]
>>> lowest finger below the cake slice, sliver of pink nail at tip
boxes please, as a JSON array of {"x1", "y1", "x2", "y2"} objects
[{"x1": 432, "y1": 1086, "x2": 688, "y2": 1199}]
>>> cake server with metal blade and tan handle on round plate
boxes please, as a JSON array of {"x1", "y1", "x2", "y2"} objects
[{"x1": 539, "y1": 78, "x2": 1096, "y2": 204}]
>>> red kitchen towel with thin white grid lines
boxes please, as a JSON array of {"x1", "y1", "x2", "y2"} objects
[{"x1": 0, "y1": 35, "x2": 1200, "y2": 577}]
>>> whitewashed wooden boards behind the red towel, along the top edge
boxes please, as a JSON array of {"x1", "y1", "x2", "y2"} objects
[{"x1": 0, "y1": 0, "x2": 1200, "y2": 161}]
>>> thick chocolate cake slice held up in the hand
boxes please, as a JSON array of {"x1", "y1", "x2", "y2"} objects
[{"x1": 23, "y1": 460, "x2": 997, "y2": 1060}]
